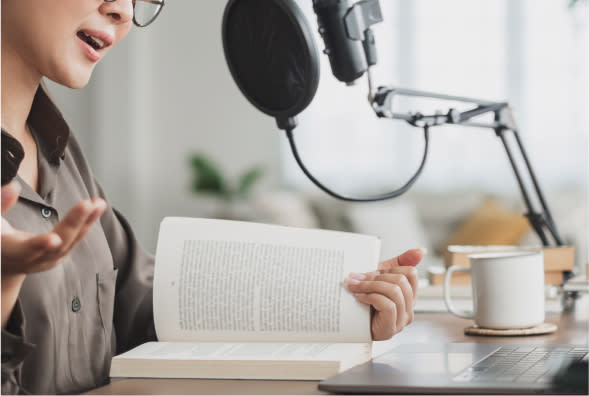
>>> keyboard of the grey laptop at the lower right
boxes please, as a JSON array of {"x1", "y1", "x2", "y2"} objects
[{"x1": 454, "y1": 345, "x2": 589, "y2": 383}]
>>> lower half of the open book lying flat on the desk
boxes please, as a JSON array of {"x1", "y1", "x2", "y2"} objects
[{"x1": 110, "y1": 342, "x2": 371, "y2": 380}]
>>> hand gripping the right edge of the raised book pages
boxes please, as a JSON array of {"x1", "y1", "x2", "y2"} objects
[{"x1": 346, "y1": 249, "x2": 426, "y2": 341}]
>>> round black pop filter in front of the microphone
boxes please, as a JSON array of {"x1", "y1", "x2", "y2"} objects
[{"x1": 222, "y1": 0, "x2": 319, "y2": 129}]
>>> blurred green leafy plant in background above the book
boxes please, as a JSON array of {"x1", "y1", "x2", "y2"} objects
[{"x1": 190, "y1": 153, "x2": 264, "y2": 202}]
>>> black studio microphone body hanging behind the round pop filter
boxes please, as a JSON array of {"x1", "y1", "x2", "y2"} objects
[{"x1": 313, "y1": 0, "x2": 383, "y2": 84}]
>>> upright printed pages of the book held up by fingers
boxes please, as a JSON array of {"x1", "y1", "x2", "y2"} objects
[{"x1": 154, "y1": 218, "x2": 380, "y2": 342}]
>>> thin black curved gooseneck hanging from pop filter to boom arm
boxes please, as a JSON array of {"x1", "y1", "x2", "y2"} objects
[{"x1": 286, "y1": 124, "x2": 429, "y2": 202}]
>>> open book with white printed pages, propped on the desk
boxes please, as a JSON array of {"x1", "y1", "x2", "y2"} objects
[{"x1": 110, "y1": 218, "x2": 380, "y2": 380}]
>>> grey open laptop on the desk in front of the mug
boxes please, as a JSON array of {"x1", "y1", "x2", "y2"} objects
[{"x1": 319, "y1": 343, "x2": 589, "y2": 395}]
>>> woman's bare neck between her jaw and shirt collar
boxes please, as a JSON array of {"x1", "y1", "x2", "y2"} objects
[{"x1": 1, "y1": 39, "x2": 42, "y2": 140}]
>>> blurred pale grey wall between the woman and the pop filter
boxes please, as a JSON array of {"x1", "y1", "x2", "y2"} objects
[{"x1": 49, "y1": 0, "x2": 283, "y2": 251}]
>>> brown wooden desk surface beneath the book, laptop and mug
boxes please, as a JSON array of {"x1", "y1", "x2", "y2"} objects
[{"x1": 87, "y1": 305, "x2": 589, "y2": 395}]
